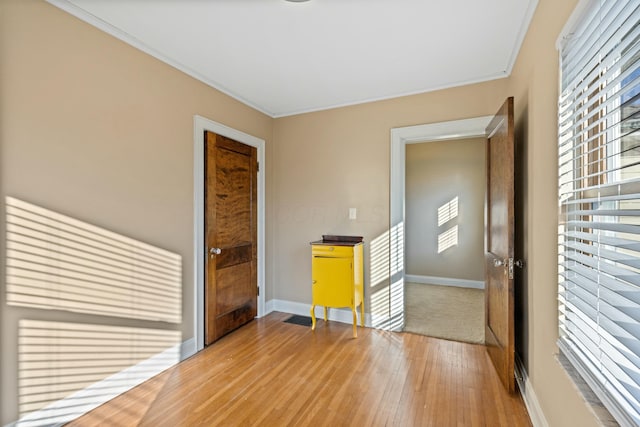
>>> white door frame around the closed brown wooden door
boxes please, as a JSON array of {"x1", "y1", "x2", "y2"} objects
[{"x1": 193, "y1": 115, "x2": 267, "y2": 351}]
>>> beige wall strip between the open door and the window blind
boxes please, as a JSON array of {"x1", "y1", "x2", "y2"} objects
[{"x1": 509, "y1": 0, "x2": 597, "y2": 426}]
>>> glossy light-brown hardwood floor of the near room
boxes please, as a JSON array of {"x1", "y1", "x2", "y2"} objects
[{"x1": 68, "y1": 313, "x2": 531, "y2": 427}]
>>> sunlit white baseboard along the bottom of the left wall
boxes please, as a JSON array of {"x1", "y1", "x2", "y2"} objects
[{"x1": 8, "y1": 338, "x2": 196, "y2": 427}]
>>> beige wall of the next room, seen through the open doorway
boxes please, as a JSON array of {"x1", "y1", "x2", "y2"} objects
[{"x1": 405, "y1": 138, "x2": 486, "y2": 281}]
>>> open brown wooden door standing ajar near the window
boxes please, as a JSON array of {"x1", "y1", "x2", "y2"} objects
[{"x1": 485, "y1": 97, "x2": 515, "y2": 392}]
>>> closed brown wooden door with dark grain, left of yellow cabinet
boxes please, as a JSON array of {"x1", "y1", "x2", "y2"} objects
[{"x1": 205, "y1": 132, "x2": 258, "y2": 345}]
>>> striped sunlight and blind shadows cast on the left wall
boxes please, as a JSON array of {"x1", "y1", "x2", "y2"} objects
[{"x1": 5, "y1": 197, "x2": 182, "y2": 425}]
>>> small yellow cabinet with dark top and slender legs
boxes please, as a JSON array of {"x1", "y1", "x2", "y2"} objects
[{"x1": 311, "y1": 236, "x2": 364, "y2": 338}]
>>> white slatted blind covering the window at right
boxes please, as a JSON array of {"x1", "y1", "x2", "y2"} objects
[{"x1": 558, "y1": 0, "x2": 640, "y2": 425}]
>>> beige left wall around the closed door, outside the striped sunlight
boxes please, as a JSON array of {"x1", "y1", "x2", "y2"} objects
[{"x1": 0, "y1": 0, "x2": 273, "y2": 424}]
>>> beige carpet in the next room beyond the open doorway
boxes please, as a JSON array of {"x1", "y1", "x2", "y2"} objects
[{"x1": 404, "y1": 283, "x2": 484, "y2": 343}]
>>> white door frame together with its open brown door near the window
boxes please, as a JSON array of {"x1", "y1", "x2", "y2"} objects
[{"x1": 389, "y1": 97, "x2": 522, "y2": 392}]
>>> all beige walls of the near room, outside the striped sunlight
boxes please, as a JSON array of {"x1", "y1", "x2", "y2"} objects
[{"x1": 0, "y1": 0, "x2": 608, "y2": 426}]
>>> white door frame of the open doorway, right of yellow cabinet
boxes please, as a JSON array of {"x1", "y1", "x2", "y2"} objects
[{"x1": 389, "y1": 116, "x2": 493, "y2": 330}]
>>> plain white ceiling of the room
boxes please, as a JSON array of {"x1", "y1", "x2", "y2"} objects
[{"x1": 48, "y1": 0, "x2": 537, "y2": 117}]
